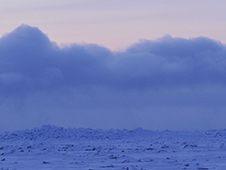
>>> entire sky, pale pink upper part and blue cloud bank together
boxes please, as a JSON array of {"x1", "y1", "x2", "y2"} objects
[{"x1": 0, "y1": 0, "x2": 226, "y2": 131}]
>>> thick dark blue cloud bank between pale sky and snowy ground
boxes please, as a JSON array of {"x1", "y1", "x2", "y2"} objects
[{"x1": 0, "y1": 25, "x2": 226, "y2": 131}]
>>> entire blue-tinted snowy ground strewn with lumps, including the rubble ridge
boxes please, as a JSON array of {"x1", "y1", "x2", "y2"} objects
[{"x1": 0, "y1": 125, "x2": 226, "y2": 170}]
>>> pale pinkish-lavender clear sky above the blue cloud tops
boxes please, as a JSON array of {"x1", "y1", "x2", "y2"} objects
[{"x1": 0, "y1": 0, "x2": 226, "y2": 50}]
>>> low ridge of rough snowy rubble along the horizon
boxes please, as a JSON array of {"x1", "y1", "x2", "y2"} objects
[{"x1": 0, "y1": 125, "x2": 226, "y2": 140}]
